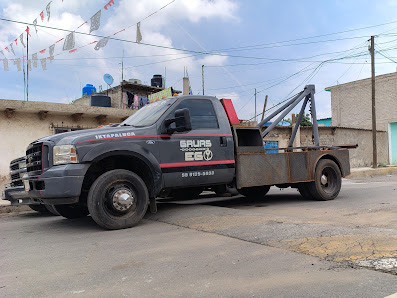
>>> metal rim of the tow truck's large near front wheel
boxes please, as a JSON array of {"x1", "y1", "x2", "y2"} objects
[{"x1": 104, "y1": 182, "x2": 137, "y2": 217}]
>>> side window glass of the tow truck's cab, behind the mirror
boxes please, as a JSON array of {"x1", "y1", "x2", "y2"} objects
[{"x1": 174, "y1": 99, "x2": 219, "y2": 129}]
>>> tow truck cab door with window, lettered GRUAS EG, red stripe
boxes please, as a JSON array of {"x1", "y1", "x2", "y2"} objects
[{"x1": 159, "y1": 98, "x2": 235, "y2": 187}]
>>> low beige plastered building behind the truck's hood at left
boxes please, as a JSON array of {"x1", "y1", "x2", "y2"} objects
[{"x1": 0, "y1": 100, "x2": 134, "y2": 190}]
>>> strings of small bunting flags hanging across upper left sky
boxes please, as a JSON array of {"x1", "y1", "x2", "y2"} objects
[{"x1": 0, "y1": 0, "x2": 145, "y2": 71}]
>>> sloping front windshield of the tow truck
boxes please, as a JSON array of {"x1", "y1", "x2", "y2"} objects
[{"x1": 120, "y1": 97, "x2": 176, "y2": 127}]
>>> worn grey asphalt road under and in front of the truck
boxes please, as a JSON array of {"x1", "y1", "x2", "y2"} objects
[{"x1": 0, "y1": 177, "x2": 397, "y2": 297}]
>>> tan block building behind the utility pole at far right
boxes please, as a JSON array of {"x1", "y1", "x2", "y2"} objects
[{"x1": 325, "y1": 73, "x2": 397, "y2": 164}]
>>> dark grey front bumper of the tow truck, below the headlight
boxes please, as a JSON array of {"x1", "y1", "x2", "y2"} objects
[{"x1": 3, "y1": 164, "x2": 89, "y2": 205}]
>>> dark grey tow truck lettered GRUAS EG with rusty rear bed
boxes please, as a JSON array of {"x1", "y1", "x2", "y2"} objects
[{"x1": 4, "y1": 85, "x2": 351, "y2": 229}]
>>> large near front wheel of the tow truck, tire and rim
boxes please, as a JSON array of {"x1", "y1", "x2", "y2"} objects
[{"x1": 87, "y1": 170, "x2": 149, "y2": 230}]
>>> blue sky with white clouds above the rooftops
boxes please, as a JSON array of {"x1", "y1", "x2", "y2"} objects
[{"x1": 0, "y1": 0, "x2": 397, "y2": 119}]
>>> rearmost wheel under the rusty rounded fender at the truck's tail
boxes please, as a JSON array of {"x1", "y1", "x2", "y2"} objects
[{"x1": 306, "y1": 159, "x2": 342, "y2": 201}]
